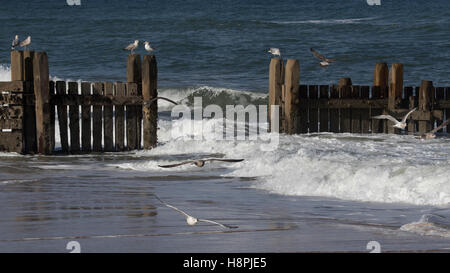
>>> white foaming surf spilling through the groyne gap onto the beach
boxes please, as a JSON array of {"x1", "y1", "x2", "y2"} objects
[{"x1": 114, "y1": 119, "x2": 450, "y2": 206}]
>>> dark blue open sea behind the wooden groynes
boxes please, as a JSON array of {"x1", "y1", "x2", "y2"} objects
[{"x1": 0, "y1": 0, "x2": 450, "y2": 92}]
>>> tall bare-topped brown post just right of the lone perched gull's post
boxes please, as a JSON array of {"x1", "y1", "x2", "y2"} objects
[{"x1": 284, "y1": 59, "x2": 300, "y2": 134}]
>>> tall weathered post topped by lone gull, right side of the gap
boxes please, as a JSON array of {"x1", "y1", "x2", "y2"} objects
[{"x1": 268, "y1": 58, "x2": 284, "y2": 132}]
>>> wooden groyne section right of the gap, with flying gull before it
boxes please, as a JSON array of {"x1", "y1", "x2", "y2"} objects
[{"x1": 269, "y1": 58, "x2": 450, "y2": 134}]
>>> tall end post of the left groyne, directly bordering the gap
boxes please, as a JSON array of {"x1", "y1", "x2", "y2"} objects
[{"x1": 142, "y1": 55, "x2": 158, "y2": 149}]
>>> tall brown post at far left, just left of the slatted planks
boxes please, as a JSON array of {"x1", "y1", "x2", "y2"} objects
[{"x1": 33, "y1": 52, "x2": 52, "y2": 154}]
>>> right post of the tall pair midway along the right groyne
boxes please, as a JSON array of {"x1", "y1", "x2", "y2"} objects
[{"x1": 387, "y1": 63, "x2": 403, "y2": 134}]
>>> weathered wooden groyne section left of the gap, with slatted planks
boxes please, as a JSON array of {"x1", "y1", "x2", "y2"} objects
[{"x1": 0, "y1": 51, "x2": 158, "y2": 154}]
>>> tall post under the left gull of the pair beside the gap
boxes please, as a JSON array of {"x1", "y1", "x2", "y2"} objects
[{"x1": 126, "y1": 54, "x2": 142, "y2": 150}]
